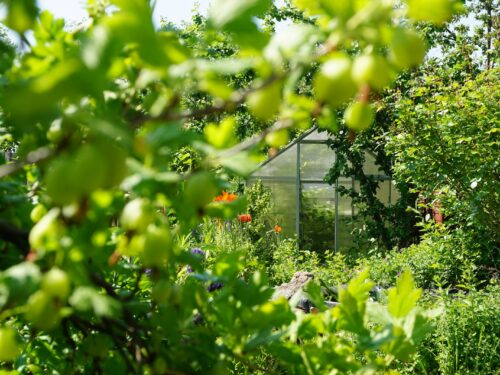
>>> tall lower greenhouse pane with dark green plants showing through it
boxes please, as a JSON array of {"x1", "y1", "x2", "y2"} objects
[{"x1": 300, "y1": 183, "x2": 335, "y2": 251}]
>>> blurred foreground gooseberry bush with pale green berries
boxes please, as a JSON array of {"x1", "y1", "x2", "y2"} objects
[{"x1": 0, "y1": 0, "x2": 457, "y2": 374}]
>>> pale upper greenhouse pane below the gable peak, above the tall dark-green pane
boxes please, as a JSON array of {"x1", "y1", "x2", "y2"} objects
[{"x1": 300, "y1": 143, "x2": 335, "y2": 181}]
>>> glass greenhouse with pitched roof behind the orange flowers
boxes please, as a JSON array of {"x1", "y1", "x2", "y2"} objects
[{"x1": 247, "y1": 128, "x2": 399, "y2": 251}]
